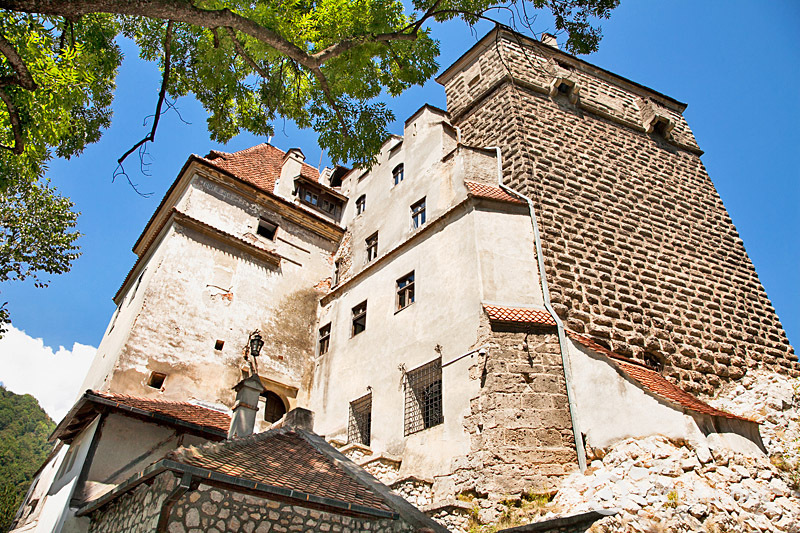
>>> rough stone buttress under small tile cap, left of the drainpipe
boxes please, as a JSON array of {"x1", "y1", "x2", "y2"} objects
[{"x1": 451, "y1": 326, "x2": 577, "y2": 500}]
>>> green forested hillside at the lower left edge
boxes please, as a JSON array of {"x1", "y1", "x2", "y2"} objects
[{"x1": 0, "y1": 386, "x2": 55, "y2": 531}]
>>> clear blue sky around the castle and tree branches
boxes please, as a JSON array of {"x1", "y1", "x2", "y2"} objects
[{"x1": 0, "y1": 0, "x2": 800, "y2": 358}]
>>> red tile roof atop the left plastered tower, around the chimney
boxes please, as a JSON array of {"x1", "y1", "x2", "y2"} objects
[{"x1": 203, "y1": 144, "x2": 319, "y2": 193}]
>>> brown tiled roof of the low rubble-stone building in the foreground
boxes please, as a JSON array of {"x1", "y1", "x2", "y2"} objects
[{"x1": 166, "y1": 429, "x2": 390, "y2": 511}]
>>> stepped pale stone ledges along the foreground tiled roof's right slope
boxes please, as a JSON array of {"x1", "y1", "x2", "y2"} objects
[{"x1": 328, "y1": 439, "x2": 472, "y2": 533}]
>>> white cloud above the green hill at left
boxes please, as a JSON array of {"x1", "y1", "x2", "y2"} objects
[{"x1": 0, "y1": 326, "x2": 97, "y2": 422}]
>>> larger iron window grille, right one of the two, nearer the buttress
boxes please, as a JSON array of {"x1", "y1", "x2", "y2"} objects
[{"x1": 404, "y1": 358, "x2": 444, "y2": 436}]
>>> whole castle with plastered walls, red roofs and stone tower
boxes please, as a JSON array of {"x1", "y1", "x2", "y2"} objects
[{"x1": 10, "y1": 28, "x2": 800, "y2": 531}]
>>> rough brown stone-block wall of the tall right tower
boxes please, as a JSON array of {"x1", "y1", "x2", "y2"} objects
[{"x1": 446, "y1": 32, "x2": 800, "y2": 393}]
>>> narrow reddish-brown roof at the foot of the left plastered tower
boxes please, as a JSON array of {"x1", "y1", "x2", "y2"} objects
[{"x1": 50, "y1": 390, "x2": 231, "y2": 442}]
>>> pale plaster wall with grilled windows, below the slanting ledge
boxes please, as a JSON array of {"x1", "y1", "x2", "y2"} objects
[{"x1": 311, "y1": 210, "x2": 481, "y2": 475}]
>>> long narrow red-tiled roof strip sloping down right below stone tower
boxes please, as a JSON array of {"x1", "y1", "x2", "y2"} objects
[{"x1": 567, "y1": 331, "x2": 753, "y2": 422}]
